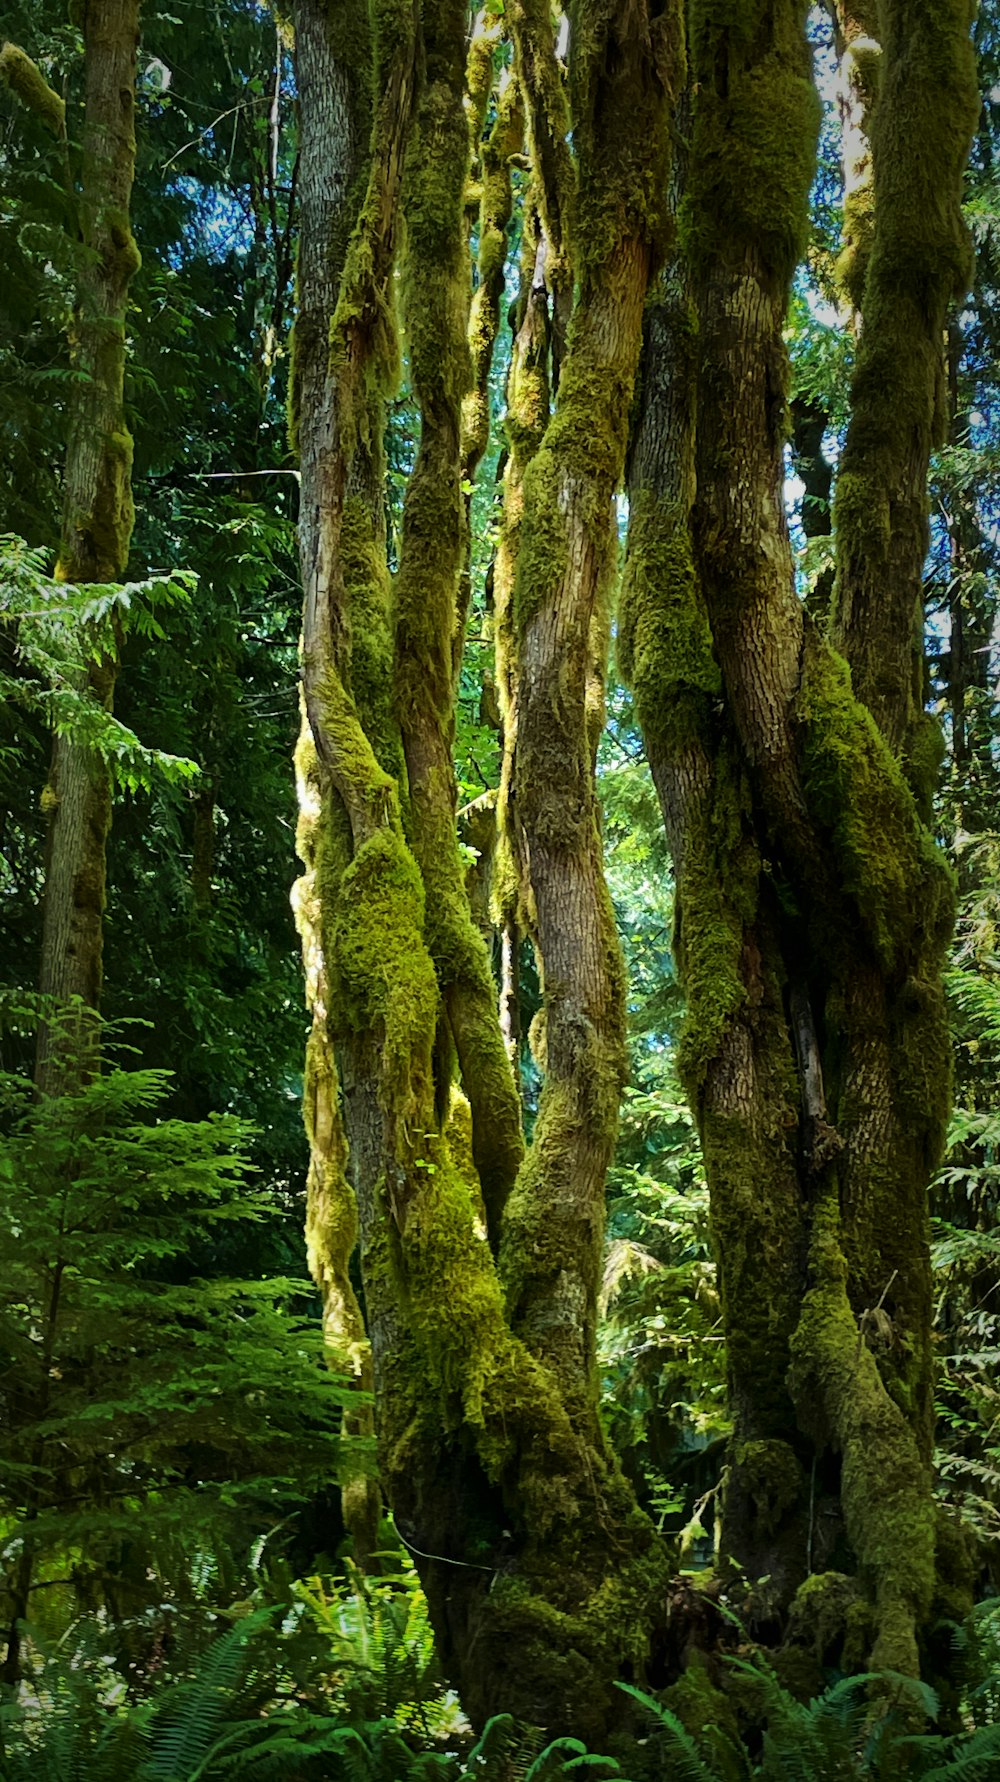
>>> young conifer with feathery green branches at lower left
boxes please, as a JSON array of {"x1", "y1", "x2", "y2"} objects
[{"x1": 0, "y1": 1040, "x2": 362, "y2": 1646}]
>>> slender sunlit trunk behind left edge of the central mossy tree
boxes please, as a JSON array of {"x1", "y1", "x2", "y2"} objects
[{"x1": 292, "y1": 0, "x2": 381, "y2": 1570}]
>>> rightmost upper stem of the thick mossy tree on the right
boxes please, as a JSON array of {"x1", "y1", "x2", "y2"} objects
[{"x1": 834, "y1": 0, "x2": 979, "y2": 748}]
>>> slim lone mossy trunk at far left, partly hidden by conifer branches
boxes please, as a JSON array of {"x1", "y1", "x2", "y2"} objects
[{"x1": 36, "y1": 0, "x2": 139, "y2": 1089}]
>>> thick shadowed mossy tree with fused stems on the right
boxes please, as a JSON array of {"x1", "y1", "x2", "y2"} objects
[{"x1": 622, "y1": 0, "x2": 975, "y2": 1672}]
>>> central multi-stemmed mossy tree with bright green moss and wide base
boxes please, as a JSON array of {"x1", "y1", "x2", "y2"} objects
[{"x1": 296, "y1": 0, "x2": 679, "y2": 1732}]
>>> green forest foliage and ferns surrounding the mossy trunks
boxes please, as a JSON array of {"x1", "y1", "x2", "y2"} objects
[{"x1": 0, "y1": 0, "x2": 1000, "y2": 1782}]
